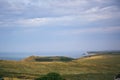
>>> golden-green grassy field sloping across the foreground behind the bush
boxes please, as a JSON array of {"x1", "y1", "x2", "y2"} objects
[{"x1": 0, "y1": 54, "x2": 120, "y2": 80}]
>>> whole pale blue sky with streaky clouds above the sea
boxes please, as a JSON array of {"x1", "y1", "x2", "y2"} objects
[{"x1": 0, "y1": 0, "x2": 120, "y2": 54}]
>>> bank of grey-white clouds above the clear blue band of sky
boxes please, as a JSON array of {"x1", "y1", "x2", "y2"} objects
[{"x1": 0, "y1": 0, "x2": 120, "y2": 27}]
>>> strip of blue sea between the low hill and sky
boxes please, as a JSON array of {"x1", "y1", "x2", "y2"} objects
[{"x1": 0, "y1": 51, "x2": 87, "y2": 61}]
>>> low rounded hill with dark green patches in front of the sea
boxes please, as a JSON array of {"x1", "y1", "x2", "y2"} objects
[{"x1": 22, "y1": 56, "x2": 74, "y2": 62}]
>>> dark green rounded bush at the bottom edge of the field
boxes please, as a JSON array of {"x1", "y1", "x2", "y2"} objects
[{"x1": 36, "y1": 72, "x2": 65, "y2": 80}]
